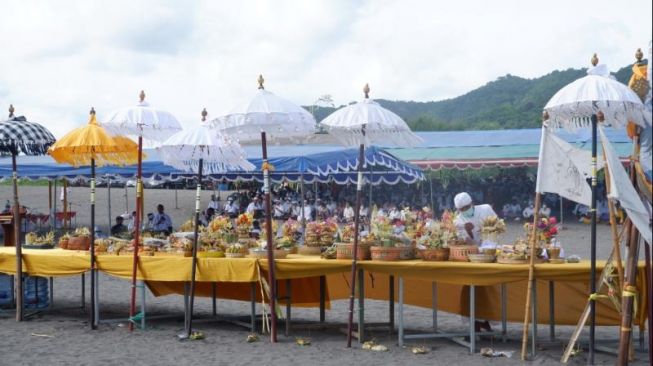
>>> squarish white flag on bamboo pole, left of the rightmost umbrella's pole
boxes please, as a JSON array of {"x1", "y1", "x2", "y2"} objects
[{"x1": 535, "y1": 126, "x2": 592, "y2": 207}]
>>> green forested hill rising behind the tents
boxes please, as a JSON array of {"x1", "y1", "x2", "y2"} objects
[{"x1": 306, "y1": 65, "x2": 632, "y2": 131}]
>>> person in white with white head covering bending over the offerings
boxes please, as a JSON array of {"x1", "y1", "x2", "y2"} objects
[{"x1": 453, "y1": 192, "x2": 497, "y2": 245}]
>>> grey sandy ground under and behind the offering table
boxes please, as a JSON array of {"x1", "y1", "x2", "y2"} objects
[{"x1": 0, "y1": 187, "x2": 649, "y2": 365}]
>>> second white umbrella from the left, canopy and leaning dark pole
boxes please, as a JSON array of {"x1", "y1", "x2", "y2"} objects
[{"x1": 159, "y1": 109, "x2": 254, "y2": 338}]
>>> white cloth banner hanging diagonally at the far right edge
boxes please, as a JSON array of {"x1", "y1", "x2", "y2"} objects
[{"x1": 599, "y1": 127, "x2": 651, "y2": 243}]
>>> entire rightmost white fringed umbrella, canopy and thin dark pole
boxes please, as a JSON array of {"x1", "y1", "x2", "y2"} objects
[{"x1": 536, "y1": 54, "x2": 651, "y2": 364}]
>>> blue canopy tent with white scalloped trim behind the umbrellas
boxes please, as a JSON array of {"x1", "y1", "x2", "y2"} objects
[{"x1": 0, "y1": 147, "x2": 424, "y2": 185}]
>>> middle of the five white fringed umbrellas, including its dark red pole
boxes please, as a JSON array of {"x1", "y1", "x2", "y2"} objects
[{"x1": 211, "y1": 75, "x2": 316, "y2": 342}]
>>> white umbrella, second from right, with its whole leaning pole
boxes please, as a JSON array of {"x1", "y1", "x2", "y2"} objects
[{"x1": 321, "y1": 84, "x2": 422, "y2": 347}]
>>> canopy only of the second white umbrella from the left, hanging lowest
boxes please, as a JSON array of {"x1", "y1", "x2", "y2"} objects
[{"x1": 159, "y1": 109, "x2": 255, "y2": 174}]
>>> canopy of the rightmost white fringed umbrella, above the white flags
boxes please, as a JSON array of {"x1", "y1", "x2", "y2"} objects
[{"x1": 544, "y1": 54, "x2": 651, "y2": 130}]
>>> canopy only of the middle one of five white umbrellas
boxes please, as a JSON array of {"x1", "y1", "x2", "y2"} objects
[{"x1": 211, "y1": 75, "x2": 316, "y2": 144}]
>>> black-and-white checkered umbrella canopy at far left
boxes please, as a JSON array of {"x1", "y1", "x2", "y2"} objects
[{"x1": 0, "y1": 105, "x2": 55, "y2": 155}]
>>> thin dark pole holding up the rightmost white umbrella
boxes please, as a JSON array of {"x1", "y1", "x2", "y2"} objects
[{"x1": 588, "y1": 114, "x2": 598, "y2": 365}]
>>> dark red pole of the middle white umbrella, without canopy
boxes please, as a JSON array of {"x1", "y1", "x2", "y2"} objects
[{"x1": 261, "y1": 132, "x2": 276, "y2": 343}]
